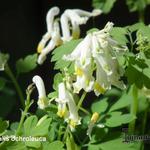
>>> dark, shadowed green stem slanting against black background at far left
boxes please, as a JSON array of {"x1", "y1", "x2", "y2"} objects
[{"x1": 5, "y1": 64, "x2": 25, "y2": 108}]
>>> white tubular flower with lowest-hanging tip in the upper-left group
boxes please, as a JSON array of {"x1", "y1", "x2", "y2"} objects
[{"x1": 37, "y1": 21, "x2": 62, "y2": 65}]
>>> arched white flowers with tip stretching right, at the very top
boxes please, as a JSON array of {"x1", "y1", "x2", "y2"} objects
[{"x1": 60, "y1": 9, "x2": 101, "y2": 41}]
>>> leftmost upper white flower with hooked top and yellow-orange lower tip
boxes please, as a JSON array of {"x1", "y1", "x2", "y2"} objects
[{"x1": 37, "y1": 7, "x2": 59, "y2": 53}]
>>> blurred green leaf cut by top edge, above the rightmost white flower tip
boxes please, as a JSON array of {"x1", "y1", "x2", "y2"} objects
[{"x1": 92, "y1": 0, "x2": 116, "y2": 14}]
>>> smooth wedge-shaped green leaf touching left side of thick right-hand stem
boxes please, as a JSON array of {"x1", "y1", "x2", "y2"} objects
[{"x1": 109, "y1": 93, "x2": 132, "y2": 112}]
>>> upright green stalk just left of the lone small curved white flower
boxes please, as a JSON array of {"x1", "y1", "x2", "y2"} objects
[{"x1": 16, "y1": 93, "x2": 31, "y2": 136}]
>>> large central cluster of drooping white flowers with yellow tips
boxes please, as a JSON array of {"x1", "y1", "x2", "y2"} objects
[{"x1": 64, "y1": 22, "x2": 127, "y2": 96}]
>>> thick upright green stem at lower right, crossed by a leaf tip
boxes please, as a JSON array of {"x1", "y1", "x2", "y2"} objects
[{"x1": 129, "y1": 85, "x2": 138, "y2": 134}]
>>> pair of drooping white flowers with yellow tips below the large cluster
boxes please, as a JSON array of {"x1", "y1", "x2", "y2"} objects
[{"x1": 56, "y1": 82, "x2": 80, "y2": 131}]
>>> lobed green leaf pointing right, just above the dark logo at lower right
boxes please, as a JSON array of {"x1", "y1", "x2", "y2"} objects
[{"x1": 105, "y1": 111, "x2": 136, "y2": 127}]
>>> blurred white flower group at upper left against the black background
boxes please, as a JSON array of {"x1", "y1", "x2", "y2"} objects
[{"x1": 37, "y1": 7, "x2": 101, "y2": 64}]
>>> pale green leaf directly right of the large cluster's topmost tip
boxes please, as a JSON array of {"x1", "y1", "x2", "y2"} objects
[{"x1": 110, "y1": 27, "x2": 128, "y2": 45}]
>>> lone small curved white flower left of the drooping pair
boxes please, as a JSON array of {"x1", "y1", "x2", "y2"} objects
[{"x1": 32, "y1": 75, "x2": 48, "y2": 109}]
